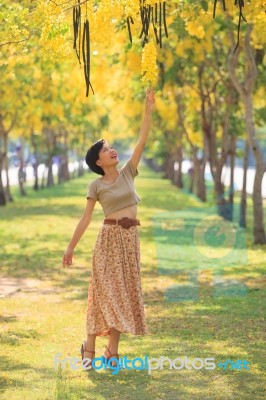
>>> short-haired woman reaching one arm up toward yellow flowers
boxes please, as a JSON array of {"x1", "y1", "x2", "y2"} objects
[{"x1": 63, "y1": 89, "x2": 154, "y2": 369}]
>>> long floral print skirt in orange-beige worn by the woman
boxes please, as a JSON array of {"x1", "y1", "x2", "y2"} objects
[{"x1": 86, "y1": 224, "x2": 148, "y2": 336}]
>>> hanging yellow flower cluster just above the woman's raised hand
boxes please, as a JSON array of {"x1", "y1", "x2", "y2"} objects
[{"x1": 141, "y1": 41, "x2": 158, "y2": 87}]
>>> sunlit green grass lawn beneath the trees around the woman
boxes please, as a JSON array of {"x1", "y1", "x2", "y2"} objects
[{"x1": 0, "y1": 164, "x2": 266, "y2": 400}]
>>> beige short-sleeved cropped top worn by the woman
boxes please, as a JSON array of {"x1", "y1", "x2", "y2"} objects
[{"x1": 87, "y1": 159, "x2": 141, "y2": 216}]
